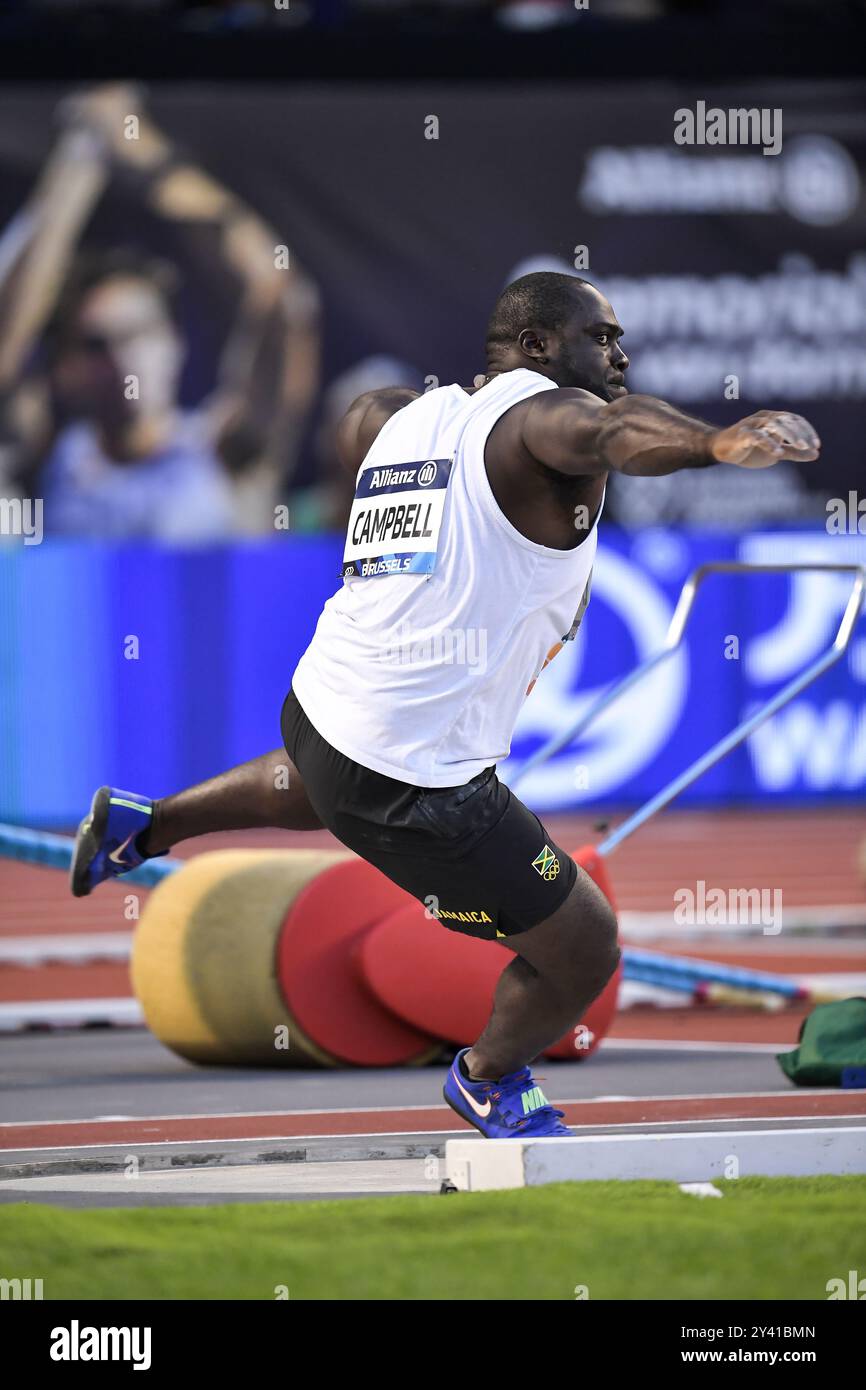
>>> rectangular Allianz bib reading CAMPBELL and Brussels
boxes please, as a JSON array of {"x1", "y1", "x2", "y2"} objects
[{"x1": 341, "y1": 459, "x2": 453, "y2": 580}]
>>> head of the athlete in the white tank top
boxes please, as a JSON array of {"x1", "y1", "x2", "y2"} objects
[{"x1": 487, "y1": 271, "x2": 628, "y2": 400}]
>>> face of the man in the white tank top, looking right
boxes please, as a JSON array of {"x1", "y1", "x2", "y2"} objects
[{"x1": 544, "y1": 286, "x2": 628, "y2": 400}]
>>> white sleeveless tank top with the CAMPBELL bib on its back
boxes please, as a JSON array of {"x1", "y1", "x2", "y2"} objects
[{"x1": 292, "y1": 368, "x2": 601, "y2": 787}]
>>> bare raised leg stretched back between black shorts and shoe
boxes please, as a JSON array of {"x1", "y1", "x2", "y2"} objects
[{"x1": 138, "y1": 748, "x2": 321, "y2": 855}]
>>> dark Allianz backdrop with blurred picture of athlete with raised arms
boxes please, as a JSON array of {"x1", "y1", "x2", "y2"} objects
[{"x1": 0, "y1": 66, "x2": 866, "y2": 543}]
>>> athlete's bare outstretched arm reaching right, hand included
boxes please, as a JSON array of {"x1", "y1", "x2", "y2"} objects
[{"x1": 520, "y1": 388, "x2": 820, "y2": 477}]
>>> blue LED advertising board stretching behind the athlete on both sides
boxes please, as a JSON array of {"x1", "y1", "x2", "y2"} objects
[{"x1": 0, "y1": 527, "x2": 866, "y2": 827}]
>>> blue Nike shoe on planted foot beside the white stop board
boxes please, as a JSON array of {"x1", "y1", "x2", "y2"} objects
[{"x1": 442, "y1": 1047, "x2": 571, "y2": 1138}]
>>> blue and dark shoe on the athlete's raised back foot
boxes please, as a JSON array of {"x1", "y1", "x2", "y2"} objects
[{"x1": 70, "y1": 787, "x2": 160, "y2": 898}]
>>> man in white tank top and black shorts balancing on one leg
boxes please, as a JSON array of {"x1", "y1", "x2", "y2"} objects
[{"x1": 72, "y1": 272, "x2": 820, "y2": 1138}]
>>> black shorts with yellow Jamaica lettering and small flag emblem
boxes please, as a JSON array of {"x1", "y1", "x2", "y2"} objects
[{"x1": 281, "y1": 691, "x2": 577, "y2": 940}]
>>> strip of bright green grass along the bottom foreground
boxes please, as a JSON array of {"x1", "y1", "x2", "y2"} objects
[{"x1": 0, "y1": 1177, "x2": 866, "y2": 1300}]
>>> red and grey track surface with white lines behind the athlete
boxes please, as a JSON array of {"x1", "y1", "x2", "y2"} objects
[{"x1": 0, "y1": 810, "x2": 866, "y2": 1207}]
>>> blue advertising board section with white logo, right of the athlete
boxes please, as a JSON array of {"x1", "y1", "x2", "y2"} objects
[{"x1": 502, "y1": 530, "x2": 866, "y2": 810}]
